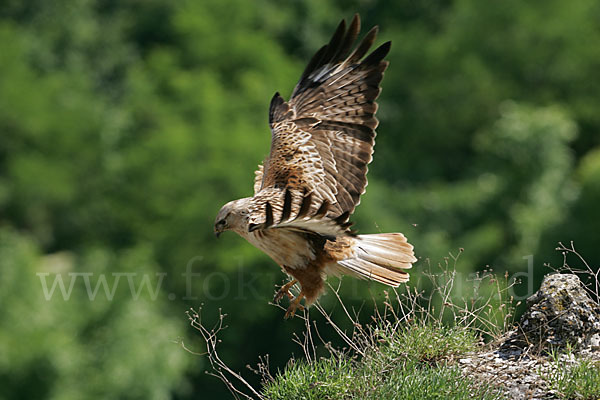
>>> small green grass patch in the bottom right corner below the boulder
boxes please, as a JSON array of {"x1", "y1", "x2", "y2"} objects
[{"x1": 548, "y1": 353, "x2": 600, "y2": 400}]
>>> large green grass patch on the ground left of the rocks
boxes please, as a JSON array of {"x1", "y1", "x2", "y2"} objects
[{"x1": 263, "y1": 324, "x2": 504, "y2": 400}]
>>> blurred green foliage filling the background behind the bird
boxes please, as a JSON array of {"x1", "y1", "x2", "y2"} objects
[{"x1": 0, "y1": 0, "x2": 600, "y2": 399}]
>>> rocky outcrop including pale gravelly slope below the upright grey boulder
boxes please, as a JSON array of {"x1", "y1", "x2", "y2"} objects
[{"x1": 459, "y1": 274, "x2": 600, "y2": 400}]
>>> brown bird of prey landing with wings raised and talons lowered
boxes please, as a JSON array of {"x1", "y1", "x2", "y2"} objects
[{"x1": 214, "y1": 15, "x2": 417, "y2": 318}]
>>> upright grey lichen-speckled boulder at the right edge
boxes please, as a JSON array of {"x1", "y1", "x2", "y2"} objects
[{"x1": 501, "y1": 274, "x2": 600, "y2": 356}]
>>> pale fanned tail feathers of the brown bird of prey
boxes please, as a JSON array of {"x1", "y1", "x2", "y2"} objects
[{"x1": 335, "y1": 233, "x2": 417, "y2": 287}]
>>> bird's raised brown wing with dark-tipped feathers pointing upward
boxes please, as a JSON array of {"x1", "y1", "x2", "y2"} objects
[{"x1": 250, "y1": 15, "x2": 390, "y2": 232}]
